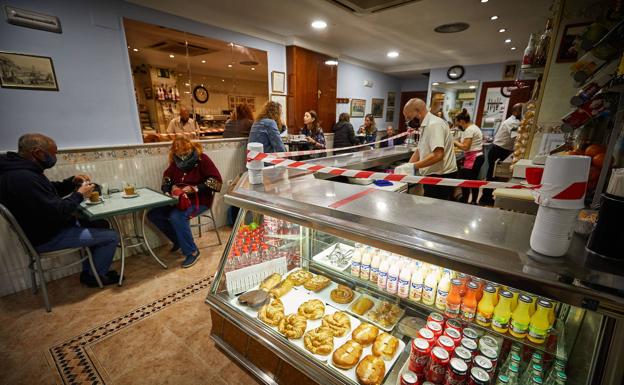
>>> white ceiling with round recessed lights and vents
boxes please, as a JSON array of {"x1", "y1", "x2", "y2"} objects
[{"x1": 129, "y1": 0, "x2": 551, "y2": 77}]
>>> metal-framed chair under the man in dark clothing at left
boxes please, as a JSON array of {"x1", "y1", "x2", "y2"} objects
[{"x1": 0, "y1": 204, "x2": 104, "y2": 312}]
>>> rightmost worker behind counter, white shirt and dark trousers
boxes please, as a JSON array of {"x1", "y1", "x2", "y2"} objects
[{"x1": 479, "y1": 103, "x2": 524, "y2": 206}]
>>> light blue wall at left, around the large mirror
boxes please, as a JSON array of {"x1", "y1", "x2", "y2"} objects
[{"x1": 0, "y1": 0, "x2": 286, "y2": 150}]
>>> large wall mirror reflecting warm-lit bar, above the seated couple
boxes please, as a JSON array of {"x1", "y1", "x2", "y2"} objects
[{"x1": 124, "y1": 19, "x2": 269, "y2": 142}]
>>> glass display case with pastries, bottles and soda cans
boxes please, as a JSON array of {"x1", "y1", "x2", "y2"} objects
[{"x1": 206, "y1": 165, "x2": 623, "y2": 385}]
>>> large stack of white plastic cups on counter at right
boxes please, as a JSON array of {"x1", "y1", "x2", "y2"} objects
[{"x1": 531, "y1": 155, "x2": 591, "y2": 257}]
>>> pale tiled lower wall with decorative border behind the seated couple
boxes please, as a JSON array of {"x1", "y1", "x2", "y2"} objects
[{"x1": 0, "y1": 139, "x2": 247, "y2": 296}]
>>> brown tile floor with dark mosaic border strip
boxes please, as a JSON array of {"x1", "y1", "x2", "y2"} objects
[{"x1": 0, "y1": 231, "x2": 256, "y2": 385}]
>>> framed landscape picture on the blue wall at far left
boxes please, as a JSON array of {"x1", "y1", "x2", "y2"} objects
[{"x1": 0, "y1": 52, "x2": 58, "y2": 91}]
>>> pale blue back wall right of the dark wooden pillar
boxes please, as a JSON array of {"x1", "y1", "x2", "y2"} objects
[{"x1": 336, "y1": 62, "x2": 401, "y2": 130}]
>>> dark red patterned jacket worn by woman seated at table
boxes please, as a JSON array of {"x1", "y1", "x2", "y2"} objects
[{"x1": 163, "y1": 153, "x2": 223, "y2": 207}]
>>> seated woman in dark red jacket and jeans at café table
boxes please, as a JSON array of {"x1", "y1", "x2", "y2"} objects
[{"x1": 147, "y1": 138, "x2": 222, "y2": 267}]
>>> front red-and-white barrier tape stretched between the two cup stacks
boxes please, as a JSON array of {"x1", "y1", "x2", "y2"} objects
[{"x1": 247, "y1": 151, "x2": 542, "y2": 190}]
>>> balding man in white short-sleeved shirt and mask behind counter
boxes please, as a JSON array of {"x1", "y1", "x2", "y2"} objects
[{"x1": 403, "y1": 98, "x2": 457, "y2": 200}]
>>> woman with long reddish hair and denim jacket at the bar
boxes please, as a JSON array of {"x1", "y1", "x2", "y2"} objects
[{"x1": 249, "y1": 100, "x2": 286, "y2": 152}]
